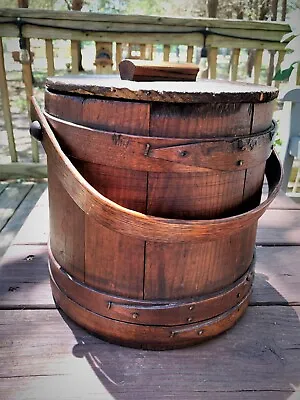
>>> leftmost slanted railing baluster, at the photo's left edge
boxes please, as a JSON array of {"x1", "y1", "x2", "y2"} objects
[{"x1": 0, "y1": 38, "x2": 18, "y2": 162}]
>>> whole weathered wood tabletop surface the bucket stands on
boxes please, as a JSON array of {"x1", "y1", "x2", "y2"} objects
[{"x1": 0, "y1": 189, "x2": 300, "y2": 400}]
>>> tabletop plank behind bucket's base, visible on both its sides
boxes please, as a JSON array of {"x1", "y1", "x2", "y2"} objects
[{"x1": 0, "y1": 245, "x2": 300, "y2": 309}]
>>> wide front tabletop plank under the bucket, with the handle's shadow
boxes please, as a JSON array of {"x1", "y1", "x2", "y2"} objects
[{"x1": 0, "y1": 306, "x2": 300, "y2": 400}]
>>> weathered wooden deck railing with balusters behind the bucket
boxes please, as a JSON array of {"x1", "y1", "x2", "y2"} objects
[{"x1": 0, "y1": 9, "x2": 290, "y2": 179}]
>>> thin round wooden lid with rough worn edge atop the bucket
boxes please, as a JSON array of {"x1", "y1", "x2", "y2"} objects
[{"x1": 46, "y1": 75, "x2": 278, "y2": 103}]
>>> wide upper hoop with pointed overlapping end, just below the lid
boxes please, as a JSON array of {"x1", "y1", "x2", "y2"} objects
[{"x1": 44, "y1": 112, "x2": 275, "y2": 173}]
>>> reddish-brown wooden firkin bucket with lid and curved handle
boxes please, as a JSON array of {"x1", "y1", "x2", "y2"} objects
[{"x1": 31, "y1": 69, "x2": 281, "y2": 349}]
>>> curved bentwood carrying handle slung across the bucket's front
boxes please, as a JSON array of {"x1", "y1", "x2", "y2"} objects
[{"x1": 32, "y1": 98, "x2": 282, "y2": 243}]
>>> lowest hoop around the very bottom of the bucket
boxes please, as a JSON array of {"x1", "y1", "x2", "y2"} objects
[{"x1": 50, "y1": 268, "x2": 251, "y2": 350}]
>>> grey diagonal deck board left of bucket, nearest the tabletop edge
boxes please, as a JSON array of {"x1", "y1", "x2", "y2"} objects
[{"x1": 0, "y1": 183, "x2": 47, "y2": 258}]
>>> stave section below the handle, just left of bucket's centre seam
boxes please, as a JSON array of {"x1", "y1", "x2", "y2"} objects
[{"x1": 84, "y1": 217, "x2": 145, "y2": 299}]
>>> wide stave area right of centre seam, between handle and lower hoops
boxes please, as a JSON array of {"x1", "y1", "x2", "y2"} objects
[{"x1": 145, "y1": 225, "x2": 256, "y2": 299}]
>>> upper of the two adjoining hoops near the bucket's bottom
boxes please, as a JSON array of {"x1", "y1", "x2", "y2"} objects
[{"x1": 49, "y1": 247, "x2": 255, "y2": 326}]
